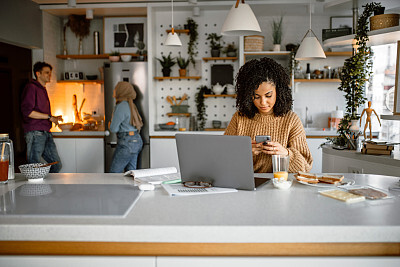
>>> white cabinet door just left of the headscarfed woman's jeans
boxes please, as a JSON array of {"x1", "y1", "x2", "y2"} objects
[{"x1": 75, "y1": 138, "x2": 104, "y2": 173}]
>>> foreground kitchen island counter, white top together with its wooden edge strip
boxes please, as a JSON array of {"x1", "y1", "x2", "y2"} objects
[{"x1": 0, "y1": 173, "x2": 400, "y2": 256}]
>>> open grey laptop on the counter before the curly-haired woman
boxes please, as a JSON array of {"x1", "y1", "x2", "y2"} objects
[{"x1": 175, "y1": 134, "x2": 268, "y2": 190}]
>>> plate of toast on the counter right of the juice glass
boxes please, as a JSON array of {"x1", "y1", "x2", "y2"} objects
[{"x1": 294, "y1": 172, "x2": 355, "y2": 187}]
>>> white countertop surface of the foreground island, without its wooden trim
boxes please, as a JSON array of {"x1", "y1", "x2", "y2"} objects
[{"x1": 0, "y1": 173, "x2": 400, "y2": 243}]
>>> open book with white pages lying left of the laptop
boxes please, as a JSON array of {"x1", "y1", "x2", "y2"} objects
[{"x1": 125, "y1": 167, "x2": 180, "y2": 184}]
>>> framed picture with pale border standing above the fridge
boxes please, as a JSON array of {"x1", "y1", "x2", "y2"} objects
[{"x1": 103, "y1": 17, "x2": 147, "y2": 54}]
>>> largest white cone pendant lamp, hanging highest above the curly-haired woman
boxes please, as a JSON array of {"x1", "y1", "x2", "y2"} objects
[{"x1": 221, "y1": 0, "x2": 261, "y2": 36}]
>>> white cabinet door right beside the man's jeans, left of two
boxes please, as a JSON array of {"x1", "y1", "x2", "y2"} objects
[{"x1": 54, "y1": 138, "x2": 76, "y2": 173}]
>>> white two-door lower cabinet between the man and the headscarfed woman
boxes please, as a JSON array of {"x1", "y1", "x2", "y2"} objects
[{"x1": 54, "y1": 138, "x2": 104, "y2": 173}]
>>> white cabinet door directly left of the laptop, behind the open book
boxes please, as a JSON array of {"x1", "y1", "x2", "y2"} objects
[{"x1": 150, "y1": 138, "x2": 179, "y2": 170}]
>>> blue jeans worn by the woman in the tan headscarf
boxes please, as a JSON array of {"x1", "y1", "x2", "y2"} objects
[{"x1": 110, "y1": 132, "x2": 143, "y2": 173}]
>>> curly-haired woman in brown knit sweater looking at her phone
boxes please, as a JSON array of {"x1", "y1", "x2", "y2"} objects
[{"x1": 225, "y1": 58, "x2": 313, "y2": 173}]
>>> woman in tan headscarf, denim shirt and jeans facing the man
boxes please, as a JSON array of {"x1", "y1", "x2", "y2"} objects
[{"x1": 110, "y1": 82, "x2": 143, "y2": 173}]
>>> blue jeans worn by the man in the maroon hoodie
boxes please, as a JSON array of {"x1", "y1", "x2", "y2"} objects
[{"x1": 25, "y1": 131, "x2": 62, "y2": 172}]
